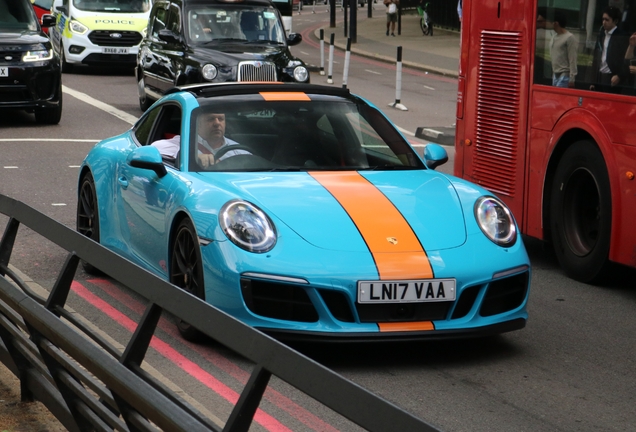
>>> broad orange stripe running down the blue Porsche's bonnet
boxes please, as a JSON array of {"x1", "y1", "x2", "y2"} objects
[{"x1": 309, "y1": 171, "x2": 433, "y2": 280}]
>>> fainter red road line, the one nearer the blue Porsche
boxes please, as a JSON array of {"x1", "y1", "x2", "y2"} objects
[{"x1": 88, "y1": 279, "x2": 338, "y2": 432}]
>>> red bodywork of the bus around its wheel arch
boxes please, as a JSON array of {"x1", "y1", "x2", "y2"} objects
[{"x1": 454, "y1": 0, "x2": 636, "y2": 274}]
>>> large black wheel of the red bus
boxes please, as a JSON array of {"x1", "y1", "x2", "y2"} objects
[{"x1": 550, "y1": 140, "x2": 612, "y2": 283}]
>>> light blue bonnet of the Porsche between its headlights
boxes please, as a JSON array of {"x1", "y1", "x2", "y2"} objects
[{"x1": 204, "y1": 170, "x2": 466, "y2": 252}]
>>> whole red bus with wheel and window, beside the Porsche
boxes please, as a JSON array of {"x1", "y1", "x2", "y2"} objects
[{"x1": 454, "y1": 0, "x2": 636, "y2": 283}]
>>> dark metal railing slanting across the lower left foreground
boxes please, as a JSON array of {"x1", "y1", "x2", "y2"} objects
[{"x1": 0, "y1": 195, "x2": 437, "y2": 432}]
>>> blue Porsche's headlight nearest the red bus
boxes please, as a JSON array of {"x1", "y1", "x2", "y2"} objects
[{"x1": 475, "y1": 196, "x2": 517, "y2": 246}]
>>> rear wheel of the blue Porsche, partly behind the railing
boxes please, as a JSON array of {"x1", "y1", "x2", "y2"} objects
[{"x1": 75, "y1": 173, "x2": 101, "y2": 275}]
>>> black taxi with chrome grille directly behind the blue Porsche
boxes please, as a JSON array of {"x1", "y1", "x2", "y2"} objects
[{"x1": 136, "y1": 0, "x2": 309, "y2": 111}]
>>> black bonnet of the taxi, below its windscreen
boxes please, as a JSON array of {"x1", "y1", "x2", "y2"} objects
[{"x1": 192, "y1": 42, "x2": 291, "y2": 65}]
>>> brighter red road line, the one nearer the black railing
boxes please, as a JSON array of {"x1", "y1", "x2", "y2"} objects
[{"x1": 71, "y1": 281, "x2": 292, "y2": 432}]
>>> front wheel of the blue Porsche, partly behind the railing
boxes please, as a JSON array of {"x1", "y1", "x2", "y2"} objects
[{"x1": 169, "y1": 218, "x2": 205, "y2": 342}]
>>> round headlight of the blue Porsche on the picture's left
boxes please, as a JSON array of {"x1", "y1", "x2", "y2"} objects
[{"x1": 219, "y1": 200, "x2": 276, "y2": 253}]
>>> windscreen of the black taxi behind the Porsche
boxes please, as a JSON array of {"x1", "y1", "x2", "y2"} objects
[{"x1": 186, "y1": 4, "x2": 285, "y2": 45}]
